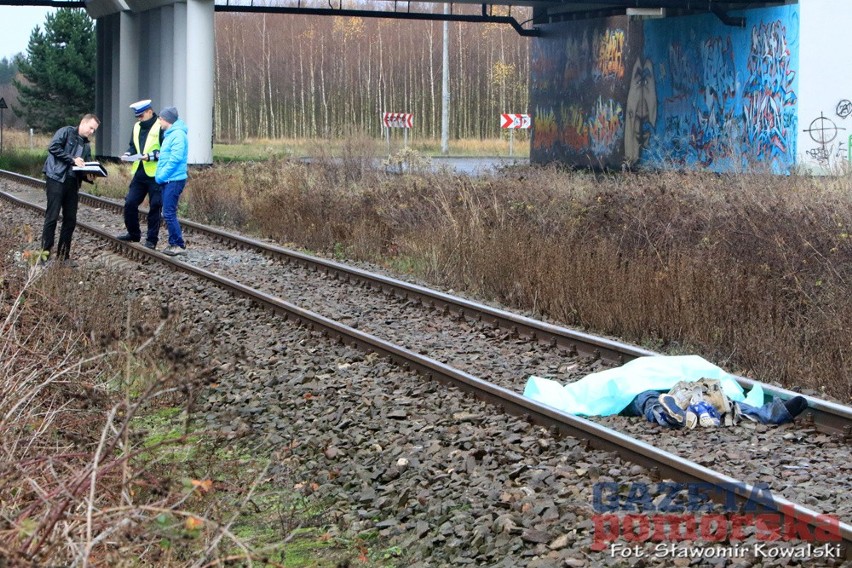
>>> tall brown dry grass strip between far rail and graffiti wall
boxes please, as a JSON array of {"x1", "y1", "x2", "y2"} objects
[{"x1": 190, "y1": 160, "x2": 852, "y2": 400}]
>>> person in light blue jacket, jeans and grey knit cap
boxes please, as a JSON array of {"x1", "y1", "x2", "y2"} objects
[{"x1": 154, "y1": 107, "x2": 189, "y2": 256}]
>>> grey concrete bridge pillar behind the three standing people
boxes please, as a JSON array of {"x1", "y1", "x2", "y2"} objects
[{"x1": 86, "y1": 0, "x2": 215, "y2": 164}]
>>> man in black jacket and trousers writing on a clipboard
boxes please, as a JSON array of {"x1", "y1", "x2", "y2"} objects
[{"x1": 41, "y1": 114, "x2": 101, "y2": 260}]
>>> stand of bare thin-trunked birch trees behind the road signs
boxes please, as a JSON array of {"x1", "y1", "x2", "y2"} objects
[{"x1": 214, "y1": 6, "x2": 530, "y2": 140}]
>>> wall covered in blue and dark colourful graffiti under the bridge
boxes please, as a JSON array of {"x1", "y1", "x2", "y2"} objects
[{"x1": 530, "y1": 6, "x2": 799, "y2": 172}]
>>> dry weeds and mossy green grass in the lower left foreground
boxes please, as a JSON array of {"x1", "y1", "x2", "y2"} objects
[{"x1": 0, "y1": 227, "x2": 366, "y2": 567}]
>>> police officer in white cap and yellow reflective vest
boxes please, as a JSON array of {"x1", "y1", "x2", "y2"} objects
[{"x1": 117, "y1": 99, "x2": 163, "y2": 249}]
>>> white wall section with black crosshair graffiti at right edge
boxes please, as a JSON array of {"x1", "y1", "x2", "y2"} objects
[{"x1": 798, "y1": 0, "x2": 852, "y2": 173}]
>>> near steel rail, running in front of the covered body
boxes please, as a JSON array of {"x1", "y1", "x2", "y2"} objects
[{"x1": 0, "y1": 183, "x2": 852, "y2": 559}]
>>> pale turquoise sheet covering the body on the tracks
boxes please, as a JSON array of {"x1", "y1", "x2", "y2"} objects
[{"x1": 524, "y1": 355, "x2": 763, "y2": 416}]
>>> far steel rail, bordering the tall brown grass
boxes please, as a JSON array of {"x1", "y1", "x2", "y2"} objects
[{"x1": 0, "y1": 170, "x2": 852, "y2": 440}]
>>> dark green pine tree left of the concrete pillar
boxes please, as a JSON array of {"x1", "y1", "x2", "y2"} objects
[{"x1": 13, "y1": 8, "x2": 96, "y2": 132}]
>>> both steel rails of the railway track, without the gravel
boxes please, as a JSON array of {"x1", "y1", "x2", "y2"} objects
[{"x1": 2, "y1": 170, "x2": 852, "y2": 555}]
